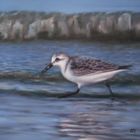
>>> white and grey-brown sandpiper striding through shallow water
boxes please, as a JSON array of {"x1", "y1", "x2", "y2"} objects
[{"x1": 41, "y1": 53, "x2": 130, "y2": 97}]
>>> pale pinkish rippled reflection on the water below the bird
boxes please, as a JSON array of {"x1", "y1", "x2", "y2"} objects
[{"x1": 56, "y1": 100, "x2": 125, "y2": 140}]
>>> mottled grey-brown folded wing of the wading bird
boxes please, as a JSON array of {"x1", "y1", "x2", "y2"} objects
[{"x1": 70, "y1": 56, "x2": 119, "y2": 76}]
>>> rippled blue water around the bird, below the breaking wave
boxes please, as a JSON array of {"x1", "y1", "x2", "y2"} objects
[{"x1": 0, "y1": 41, "x2": 140, "y2": 140}]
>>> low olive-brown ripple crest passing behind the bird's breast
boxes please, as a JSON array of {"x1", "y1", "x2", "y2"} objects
[{"x1": 0, "y1": 72, "x2": 140, "y2": 84}]
